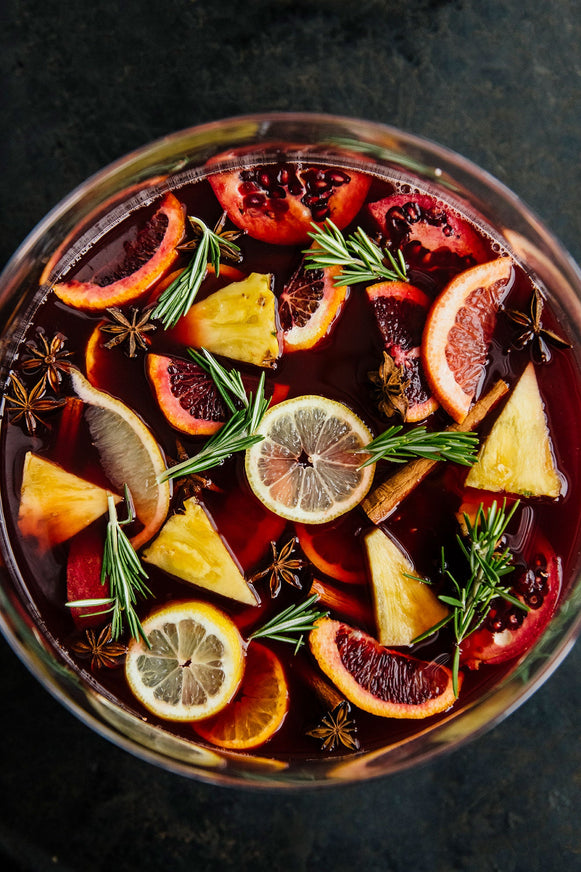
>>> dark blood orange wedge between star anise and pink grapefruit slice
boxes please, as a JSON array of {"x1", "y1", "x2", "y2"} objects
[{"x1": 367, "y1": 282, "x2": 438, "y2": 421}]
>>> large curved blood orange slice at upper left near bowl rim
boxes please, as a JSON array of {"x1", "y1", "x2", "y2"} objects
[{"x1": 54, "y1": 194, "x2": 185, "y2": 311}]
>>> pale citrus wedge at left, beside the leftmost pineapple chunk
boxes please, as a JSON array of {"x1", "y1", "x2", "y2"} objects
[{"x1": 71, "y1": 369, "x2": 170, "y2": 548}]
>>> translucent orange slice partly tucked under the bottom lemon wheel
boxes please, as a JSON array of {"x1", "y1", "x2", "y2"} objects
[{"x1": 196, "y1": 642, "x2": 289, "y2": 751}]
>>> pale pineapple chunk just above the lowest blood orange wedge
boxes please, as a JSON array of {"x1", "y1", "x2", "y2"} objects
[{"x1": 365, "y1": 528, "x2": 448, "y2": 646}]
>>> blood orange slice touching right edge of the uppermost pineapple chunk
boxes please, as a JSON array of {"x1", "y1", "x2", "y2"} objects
[{"x1": 278, "y1": 252, "x2": 348, "y2": 352}]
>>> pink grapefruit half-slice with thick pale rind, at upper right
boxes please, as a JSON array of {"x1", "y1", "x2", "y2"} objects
[{"x1": 422, "y1": 257, "x2": 512, "y2": 422}]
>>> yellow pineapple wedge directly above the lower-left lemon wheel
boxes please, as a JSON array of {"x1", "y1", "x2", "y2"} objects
[{"x1": 143, "y1": 498, "x2": 257, "y2": 606}]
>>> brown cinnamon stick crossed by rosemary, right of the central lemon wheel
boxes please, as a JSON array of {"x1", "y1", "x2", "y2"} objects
[{"x1": 361, "y1": 379, "x2": 508, "y2": 524}]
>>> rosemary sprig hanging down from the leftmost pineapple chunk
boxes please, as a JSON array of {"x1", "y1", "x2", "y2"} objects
[{"x1": 67, "y1": 485, "x2": 152, "y2": 647}]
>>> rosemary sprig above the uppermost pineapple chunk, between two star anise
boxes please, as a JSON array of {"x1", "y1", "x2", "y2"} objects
[{"x1": 152, "y1": 215, "x2": 240, "y2": 330}]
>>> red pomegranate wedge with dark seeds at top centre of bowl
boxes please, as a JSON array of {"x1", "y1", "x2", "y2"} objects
[{"x1": 210, "y1": 152, "x2": 371, "y2": 245}]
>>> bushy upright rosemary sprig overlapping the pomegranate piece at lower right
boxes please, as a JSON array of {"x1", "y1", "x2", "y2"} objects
[{"x1": 414, "y1": 501, "x2": 527, "y2": 696}]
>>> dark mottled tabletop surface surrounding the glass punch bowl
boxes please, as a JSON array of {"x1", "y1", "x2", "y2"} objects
[{"x1": 0, "y1": 0, "x2": 581, "y2": 872}]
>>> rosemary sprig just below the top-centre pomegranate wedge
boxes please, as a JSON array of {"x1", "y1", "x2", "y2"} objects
[{"x1": 303, "y1": 218, "x2": 408, "y2": 287}]
